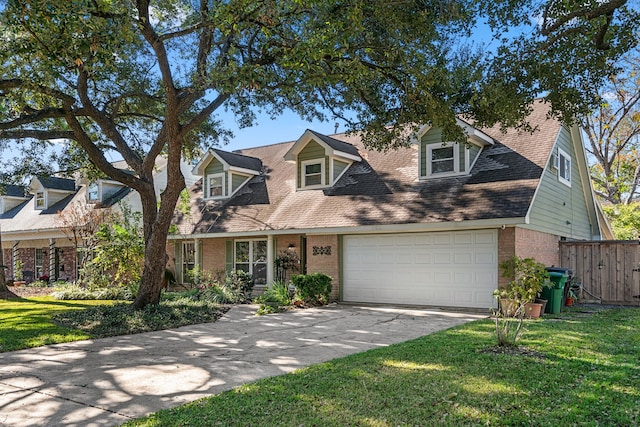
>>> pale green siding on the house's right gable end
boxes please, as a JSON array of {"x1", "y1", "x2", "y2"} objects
[{"x1": 530, "y1": 127, "x2": 595, "y2": 240}]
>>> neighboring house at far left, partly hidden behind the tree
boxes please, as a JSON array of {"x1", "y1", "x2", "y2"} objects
[{"x1": 0, "y1": 158, "x2": 196, "y2": 281}]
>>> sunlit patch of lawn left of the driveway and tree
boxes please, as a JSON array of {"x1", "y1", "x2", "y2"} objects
[{"x1": 0, "y1": 297, "x2": 112, "y2": 352}]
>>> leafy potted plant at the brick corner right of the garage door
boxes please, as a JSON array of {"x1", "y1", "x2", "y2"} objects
[{"x1": 494, "y1": 256, "x2": 551, "y2": 318}]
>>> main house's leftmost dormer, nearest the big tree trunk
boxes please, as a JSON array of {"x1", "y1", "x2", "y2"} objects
[{"x1": 192, "y1": 149, "x2": 262, "y2": 200}]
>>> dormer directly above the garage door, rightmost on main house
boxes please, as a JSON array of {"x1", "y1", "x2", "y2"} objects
[{"x1": 417, "y1": 119, "x2": 494, "y2": 179}]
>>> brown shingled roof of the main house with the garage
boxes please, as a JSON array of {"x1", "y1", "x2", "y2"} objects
[{"x1": 176, "y1": 103, "x2": 561, "y2": 234}]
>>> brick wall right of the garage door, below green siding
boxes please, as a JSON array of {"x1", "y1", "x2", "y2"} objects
[{"x1": 498, "y1": 227, "x2": 560, "y2": 287}]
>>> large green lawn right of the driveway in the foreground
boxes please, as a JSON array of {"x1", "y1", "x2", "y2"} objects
[{"x1": 126, "y1": 309, "x2": 640, "y2": 427}]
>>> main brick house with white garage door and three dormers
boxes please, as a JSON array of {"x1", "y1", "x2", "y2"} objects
[{"x1": 168, "y1": 103, "x2": 613, "y2": 308}]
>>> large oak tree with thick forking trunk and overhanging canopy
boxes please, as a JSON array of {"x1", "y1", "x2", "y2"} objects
[{"x1": 0, "y1": 0, "x2": 638, "y2": 308}]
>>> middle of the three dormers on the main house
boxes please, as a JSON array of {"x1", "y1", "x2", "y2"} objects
[{"x1": 284, "y1": 129, "x2": 362, "y2": 190}]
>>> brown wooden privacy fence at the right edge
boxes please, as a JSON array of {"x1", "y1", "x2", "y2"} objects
[{"x1": 560, "y1": 240, "x2": 640, "y2": 305}]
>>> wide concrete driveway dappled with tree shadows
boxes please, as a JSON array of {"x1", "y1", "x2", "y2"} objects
[{"x1": 0, "y1": 305, "x2": 486, "y2": 426}]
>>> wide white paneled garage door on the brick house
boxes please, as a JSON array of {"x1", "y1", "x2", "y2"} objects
[{"x1": 342, "y1": 230, "x2": 498, "y2": 308}]
